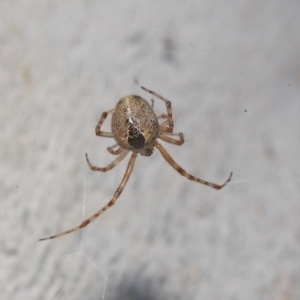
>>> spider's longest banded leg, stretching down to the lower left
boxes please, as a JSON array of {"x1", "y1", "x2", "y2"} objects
[{"x1": 39, "y1": 153, "x2": 138, "y2": 241}]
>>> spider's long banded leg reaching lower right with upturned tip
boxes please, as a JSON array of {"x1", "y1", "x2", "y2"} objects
[{"x1": 155, "y1": 142, "x2": 232, "y2": 190}]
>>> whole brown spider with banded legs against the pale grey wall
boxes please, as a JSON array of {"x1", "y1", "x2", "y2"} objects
[{"x1": 40, "y1": 86, "x2": 232, "y2": 241}]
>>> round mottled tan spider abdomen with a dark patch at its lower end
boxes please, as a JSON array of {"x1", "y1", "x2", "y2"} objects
[{"x1": 111, "y1": 95, "x2": 159, "y2": 151}]
